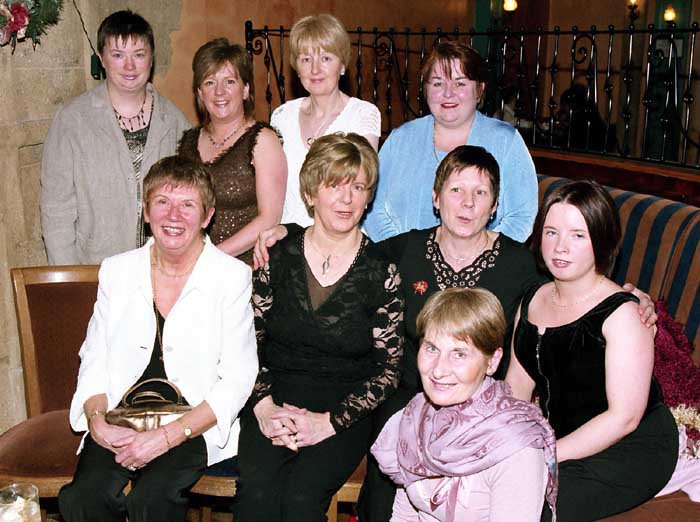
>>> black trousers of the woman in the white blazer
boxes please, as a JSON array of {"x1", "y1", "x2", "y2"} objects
[{"x1": 58, "y1": 435, "x2": 207, "y2": 522}]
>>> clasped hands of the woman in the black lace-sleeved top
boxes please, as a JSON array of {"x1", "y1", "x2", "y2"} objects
[{"x1": 253, "y1": 396, "x2": 335, "y2": 451}]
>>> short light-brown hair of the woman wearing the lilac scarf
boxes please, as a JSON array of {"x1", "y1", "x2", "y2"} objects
[{"x1": 416, "y1": 288, "x2": 506, "y2": 357}]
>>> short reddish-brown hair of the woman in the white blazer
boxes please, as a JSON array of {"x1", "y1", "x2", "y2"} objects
[{"x1": 143, "y1": 156, "x2": 216, "y2": 215}]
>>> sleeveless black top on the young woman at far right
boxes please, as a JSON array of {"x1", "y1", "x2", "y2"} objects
[{"x1": 514, "y1": 287, "x2": 663, "y2": 438}]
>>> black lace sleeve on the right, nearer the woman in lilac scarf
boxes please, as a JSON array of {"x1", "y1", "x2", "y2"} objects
[{"x1": 330, "y1": 263, "x2": 404, "y2": 432}]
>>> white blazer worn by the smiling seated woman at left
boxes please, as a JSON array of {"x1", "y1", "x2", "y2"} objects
[{"x1": 70, "y1": 237, "x2": 258, "y2": 464}]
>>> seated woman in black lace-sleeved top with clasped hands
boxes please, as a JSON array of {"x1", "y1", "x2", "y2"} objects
[{"x1": 234, "y1": 134, "x2": 403, "y2": 522}]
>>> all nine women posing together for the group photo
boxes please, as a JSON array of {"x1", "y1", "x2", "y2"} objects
[{"x1": 42, "y1": 7, "x2": 692, "y2": 522}]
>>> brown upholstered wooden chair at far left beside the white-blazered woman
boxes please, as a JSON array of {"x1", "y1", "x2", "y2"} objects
[{"x1": 0, "y1": 266, "x2": 98, "y2": 508}]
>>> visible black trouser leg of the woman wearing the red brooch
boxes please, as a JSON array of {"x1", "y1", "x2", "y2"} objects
[{"x1": 357, "y1": 382, "x2": 420, "y2": 522}]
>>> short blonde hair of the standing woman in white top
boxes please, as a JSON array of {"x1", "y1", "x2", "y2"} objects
[{"x1": 289, "y1": 14, "x2": 350, "y2": 70}]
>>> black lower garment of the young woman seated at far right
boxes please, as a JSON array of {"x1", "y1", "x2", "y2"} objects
[{"x1": 540, "y1": 404, "x2": 678, "y2": 522}]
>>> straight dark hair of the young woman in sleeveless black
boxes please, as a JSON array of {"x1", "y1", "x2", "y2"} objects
[{"x1": 531, "y1": 180, "x2": 622, "y2": 275}]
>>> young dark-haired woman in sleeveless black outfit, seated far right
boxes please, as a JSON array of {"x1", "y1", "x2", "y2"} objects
[{"x1": 506, "y1": 181, "x2": 678, "y2": 522}]
